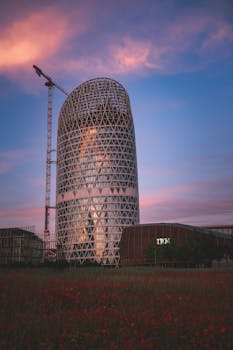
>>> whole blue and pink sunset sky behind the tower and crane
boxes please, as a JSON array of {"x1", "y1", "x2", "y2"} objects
[{"x1": 0, "y1": 0, "x2": 233, "y2": 238}]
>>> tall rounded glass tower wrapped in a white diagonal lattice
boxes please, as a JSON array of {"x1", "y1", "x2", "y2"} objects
[{"x1": 56, "y1": 78, "x2": 139, "y2": 265}]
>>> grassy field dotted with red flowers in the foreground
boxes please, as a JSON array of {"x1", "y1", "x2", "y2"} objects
[{"x1": 0, "y1": 267, "x2": 233, "y2": 350}]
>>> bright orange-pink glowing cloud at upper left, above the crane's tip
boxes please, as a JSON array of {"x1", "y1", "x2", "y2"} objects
[{"x1": 0, "y1": 8, "x2": 70, "y2": 70}]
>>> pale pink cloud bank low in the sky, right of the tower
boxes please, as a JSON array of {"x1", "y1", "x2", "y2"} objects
[{"x1": 140, "y1": 180, "x2": 233, "y2": 225}]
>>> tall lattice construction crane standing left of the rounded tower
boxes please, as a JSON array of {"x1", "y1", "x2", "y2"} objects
[{"x1": 33, "y1": 65, "x2": 68, "y2": 249}]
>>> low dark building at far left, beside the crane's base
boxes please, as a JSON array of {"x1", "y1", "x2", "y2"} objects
[{"x1": 0, "y1": 228, "x2": 43, "y2": 265}]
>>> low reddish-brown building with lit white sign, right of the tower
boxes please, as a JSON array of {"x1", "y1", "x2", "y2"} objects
[{"x1": 120, "y1": 223, "x2": 233, "y2": 266}]
